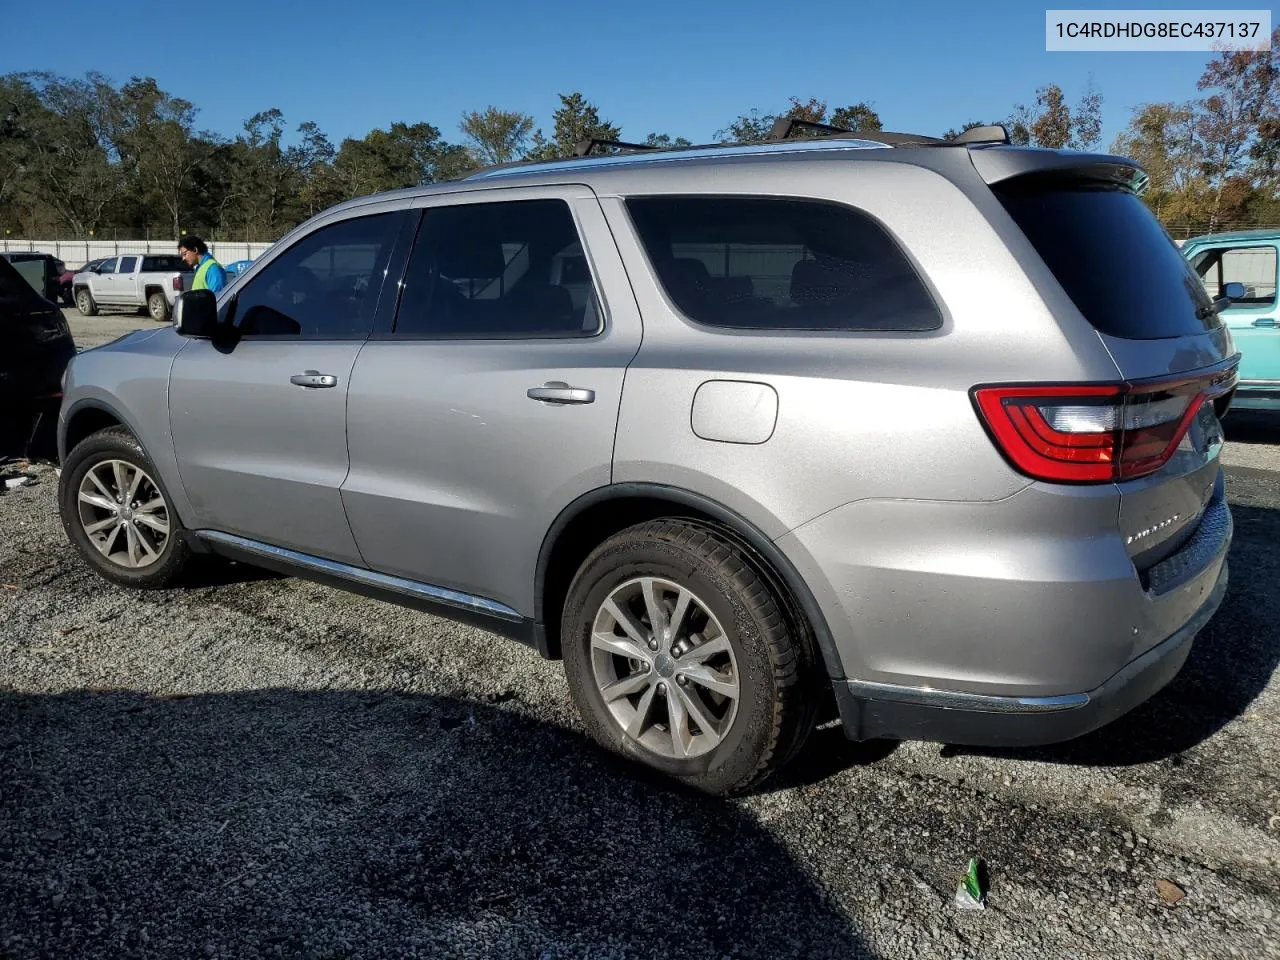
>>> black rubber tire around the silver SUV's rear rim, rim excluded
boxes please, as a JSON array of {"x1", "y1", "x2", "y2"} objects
[{"x1": 561, "y1": 520, "x2": 820, "y2": 795}]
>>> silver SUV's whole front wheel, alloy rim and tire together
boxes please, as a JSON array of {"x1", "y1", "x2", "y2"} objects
[{"x1": 58, "y1": 428, "x2": 189, "y2": 588}]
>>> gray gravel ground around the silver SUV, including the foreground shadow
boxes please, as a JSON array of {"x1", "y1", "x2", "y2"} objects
[{"x1": 0, "y1": 445, "x2": 1280, "y2": 960}]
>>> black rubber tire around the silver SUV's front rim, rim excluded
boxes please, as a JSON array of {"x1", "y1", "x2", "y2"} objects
[{"x1": 58, "y1": 426, "x2": 191, "y2": 589}]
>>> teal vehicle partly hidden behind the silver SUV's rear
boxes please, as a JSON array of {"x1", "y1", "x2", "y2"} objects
[{"x1": 1183, "y1": 229, "x2": 1280, "y2": 412}]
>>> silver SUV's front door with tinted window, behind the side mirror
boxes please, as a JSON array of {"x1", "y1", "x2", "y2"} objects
[{"x1": 169, "y1": 210, "x2": 410, "y2": 563}]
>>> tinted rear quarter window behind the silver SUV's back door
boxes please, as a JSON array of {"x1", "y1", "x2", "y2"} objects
[{"x1": 627, "y1": 196, "x2": 942, "y2": 332}]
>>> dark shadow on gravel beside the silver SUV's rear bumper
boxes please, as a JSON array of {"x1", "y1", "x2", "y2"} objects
[{"x1": 945, "y1": 503, "x2": 1280, "y2": 767}]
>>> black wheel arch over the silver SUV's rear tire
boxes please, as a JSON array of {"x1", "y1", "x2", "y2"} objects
[{"x1": 534, "y1": 483, "x2": 845, "y2": 680}]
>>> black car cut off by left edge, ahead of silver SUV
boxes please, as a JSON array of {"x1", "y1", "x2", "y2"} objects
[{"x1": 0, "y1": 257, "x2": 76, "y2": 453}]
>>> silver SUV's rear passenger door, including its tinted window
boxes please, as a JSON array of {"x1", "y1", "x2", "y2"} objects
[{"x1": 343, "y1": 186, "x2": 640, "y2": 616}]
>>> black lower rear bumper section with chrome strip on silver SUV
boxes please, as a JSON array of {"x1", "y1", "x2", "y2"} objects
[{"x1": 835, "y1": 562, "x2": 1228, "y2": 746}]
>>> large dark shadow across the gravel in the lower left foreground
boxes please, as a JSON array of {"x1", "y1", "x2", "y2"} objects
[{"x1": 0, "y1": 690, "x2": 872, "y2": 957}]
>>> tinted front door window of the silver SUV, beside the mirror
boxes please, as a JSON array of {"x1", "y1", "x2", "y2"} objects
[{"x1": 234, "y1": 214, "x2": 399, "y2": 339}]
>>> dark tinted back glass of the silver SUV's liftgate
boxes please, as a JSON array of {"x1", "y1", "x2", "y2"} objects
[{"x1": 995, "y1": 179, "x2": 1219, "y2": 340}]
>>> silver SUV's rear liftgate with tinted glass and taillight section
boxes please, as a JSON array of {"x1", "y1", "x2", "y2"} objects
[{"x1": 977, "y1": 163, "x2": 1238, "y2": 576}]
